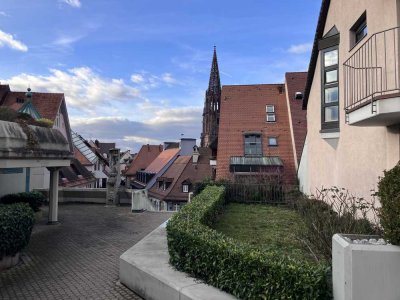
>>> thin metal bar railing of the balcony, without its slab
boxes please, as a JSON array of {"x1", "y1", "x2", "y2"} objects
[{"x1": 343, "y1": 27, "x2": 400, "y2": 112}]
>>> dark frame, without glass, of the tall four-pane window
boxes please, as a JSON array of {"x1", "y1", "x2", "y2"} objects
[{"x1": 320, "y1": 45, "x2": 340, "y2": 131}]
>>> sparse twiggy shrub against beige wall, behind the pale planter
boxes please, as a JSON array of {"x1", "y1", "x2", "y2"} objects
[{"x1": 295, "y1": 187, "x2": 381, "y2": 261}]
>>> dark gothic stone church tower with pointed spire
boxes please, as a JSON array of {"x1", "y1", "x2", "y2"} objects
[{"x1": 201, "y1": 46, "x2": 221, "y2": 156}]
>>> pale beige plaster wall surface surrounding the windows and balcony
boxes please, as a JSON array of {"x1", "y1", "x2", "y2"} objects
[{"x1": 300, "y1": 0, "x2": 400, "y2": 198}]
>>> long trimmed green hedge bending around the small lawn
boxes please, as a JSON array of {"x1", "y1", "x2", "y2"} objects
[{"x1": 167, "y1": 186, "x2": 330, "y2": 299}]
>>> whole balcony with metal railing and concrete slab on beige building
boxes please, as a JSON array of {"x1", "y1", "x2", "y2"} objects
[{"x1": 343, "y1": 27, "x2": 400, "y2": 126}]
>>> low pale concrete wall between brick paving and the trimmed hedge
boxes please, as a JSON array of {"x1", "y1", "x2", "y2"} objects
[{"x1": 119, "y1": 225, "x2": 237, "y2": 300}]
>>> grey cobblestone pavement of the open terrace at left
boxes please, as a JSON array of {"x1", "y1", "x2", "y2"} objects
[{"x1": 0, "y1": 204, "x2": 171, "y2": 300}]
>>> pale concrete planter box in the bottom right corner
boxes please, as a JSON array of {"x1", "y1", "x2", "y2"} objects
[{"x1": 332, "y1": 234, "x2": 400, "y2": 300}]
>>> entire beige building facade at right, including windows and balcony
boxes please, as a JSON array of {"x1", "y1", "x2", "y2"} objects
[{"x1": 298, "y1": 0, "x2": 400, "y2": 199}]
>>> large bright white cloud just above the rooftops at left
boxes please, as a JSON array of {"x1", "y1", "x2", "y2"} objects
[{"x1": 1, "y1": 67, "x2": 144, "y2": 114}]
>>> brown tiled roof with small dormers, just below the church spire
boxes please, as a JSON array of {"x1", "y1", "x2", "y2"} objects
[{"x1": 149, "y1": 147, "x2": 212, "y2": 201}]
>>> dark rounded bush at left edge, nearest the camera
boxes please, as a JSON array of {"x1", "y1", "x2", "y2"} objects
[{"x1": 0, "y1": 203, "x2": 34, "y2": 259}]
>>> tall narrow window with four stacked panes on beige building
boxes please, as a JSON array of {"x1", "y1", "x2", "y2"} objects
[{"x1": 321, "y1": 46, "x2": 339, "y2": 130}]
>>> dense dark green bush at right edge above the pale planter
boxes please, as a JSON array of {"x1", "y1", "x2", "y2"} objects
[{"x1": 378, "y1": 163, "x2": 400, "y2": 245}]
